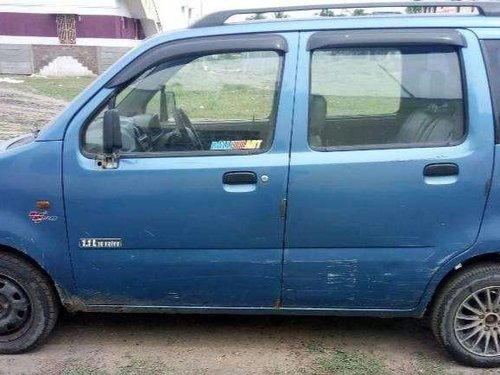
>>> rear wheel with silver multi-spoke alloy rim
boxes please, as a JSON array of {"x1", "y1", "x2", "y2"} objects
[{"x1": 430, "y1": 262, "x2": 500, "y2": 368}]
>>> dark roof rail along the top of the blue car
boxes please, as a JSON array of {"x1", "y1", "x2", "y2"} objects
[{"x1": 191, "y1": 0, "x2": 500, "y2": 28}]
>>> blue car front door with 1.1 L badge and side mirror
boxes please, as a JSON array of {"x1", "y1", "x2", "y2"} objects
[{"x1": 64, "y1": 33, "x2": 298, "y2": 308}]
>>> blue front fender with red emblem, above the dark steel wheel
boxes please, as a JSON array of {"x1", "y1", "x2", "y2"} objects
[{"x1": 0, "y1": 141, "x2": 74, "y2": 293}]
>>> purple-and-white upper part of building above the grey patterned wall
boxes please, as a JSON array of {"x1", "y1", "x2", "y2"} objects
[{"x1": 0, "y1": 0, "x2": 161, "y2": 46}]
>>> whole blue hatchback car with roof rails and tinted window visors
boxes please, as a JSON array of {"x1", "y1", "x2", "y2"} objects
[{"x1": 0, "y1": 2, "x2": 500, "y2": 367}]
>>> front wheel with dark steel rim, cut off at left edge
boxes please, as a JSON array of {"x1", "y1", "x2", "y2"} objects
[{"x1": 0, "y1": 253, "x2": 59, "y2": 354}]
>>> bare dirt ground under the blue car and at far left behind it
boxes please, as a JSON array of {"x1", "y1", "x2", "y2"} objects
[{"x1": 0, "y1": 78, "x2": 500, "y2": 375}]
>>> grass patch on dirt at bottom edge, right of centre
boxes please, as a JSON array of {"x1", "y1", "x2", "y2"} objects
[{"x1": 315, "y1": 350, "x2": 390, "y2": 375}]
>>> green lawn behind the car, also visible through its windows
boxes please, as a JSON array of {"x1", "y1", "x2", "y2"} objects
[{"x1": 0, "y1": 71, "x2": 399, "y2": 120}]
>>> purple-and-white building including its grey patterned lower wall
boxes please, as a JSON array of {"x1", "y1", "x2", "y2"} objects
[{"x1": 0, "y1": 0, "x2": 201, "y2": 75}]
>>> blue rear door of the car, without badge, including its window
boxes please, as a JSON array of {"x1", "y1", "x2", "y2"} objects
[{"x1": 283, "y1": 29, "x2": 494, "y2": 310}]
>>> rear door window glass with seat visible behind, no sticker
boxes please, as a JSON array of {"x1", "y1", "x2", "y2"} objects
[{"x1": 308, "y1": 45, "x2": 465, "y2": 151}]
